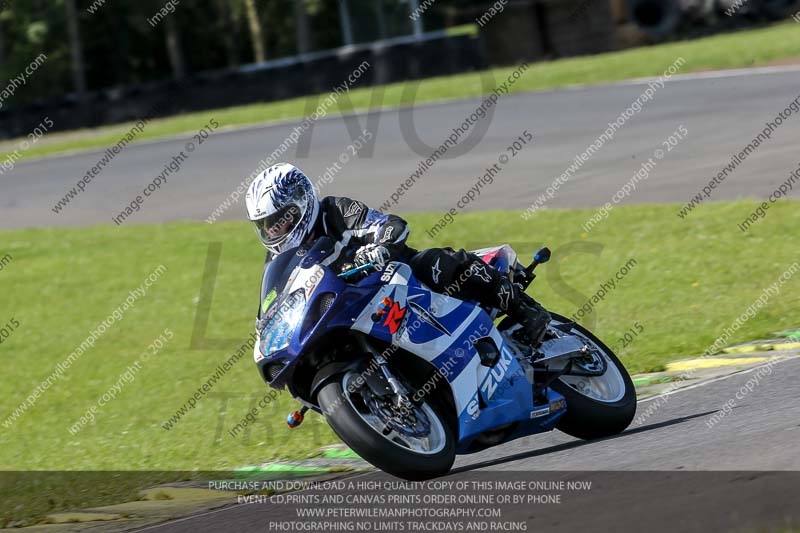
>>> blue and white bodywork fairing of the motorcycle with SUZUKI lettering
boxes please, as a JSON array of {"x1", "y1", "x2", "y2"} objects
[{"x1": 255, "y1": 242, "x2": 565, "y2": 453}]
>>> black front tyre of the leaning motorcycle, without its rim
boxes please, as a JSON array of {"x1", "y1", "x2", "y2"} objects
[{"x1": 317, "y1": 374, "x2": 456, "y2": 481}]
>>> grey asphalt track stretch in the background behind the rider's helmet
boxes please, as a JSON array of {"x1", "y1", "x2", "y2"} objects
[{"x1": 0, "y1": 65, "x2": 800, "y2": 229}]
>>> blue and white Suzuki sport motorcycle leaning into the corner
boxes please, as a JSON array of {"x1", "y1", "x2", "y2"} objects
[{"x1": 255, "y1": 237, "x2": 636, "y2": 480}]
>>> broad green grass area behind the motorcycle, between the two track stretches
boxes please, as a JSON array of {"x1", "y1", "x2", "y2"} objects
[{"x1": 0, "y1": 201, "x2": 800, "y2": 523}]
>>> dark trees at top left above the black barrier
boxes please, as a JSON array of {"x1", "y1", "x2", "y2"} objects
[{"x1": 0, "y1": 0, "x2": 466, "y2": 106}]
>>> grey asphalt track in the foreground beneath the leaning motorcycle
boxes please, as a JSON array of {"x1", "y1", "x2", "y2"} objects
[{"x1": 141, "y1": 359, "x2": 800, "y2": 533}]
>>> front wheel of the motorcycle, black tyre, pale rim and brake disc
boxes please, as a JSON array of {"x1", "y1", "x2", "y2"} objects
[{"x1": 317, "y1": 371, "x2": 456, "y2": 481}]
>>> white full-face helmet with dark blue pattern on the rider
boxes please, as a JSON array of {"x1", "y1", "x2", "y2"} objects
[{"x1": 245, "y1": 163, "x2": 319, "y2": 255}]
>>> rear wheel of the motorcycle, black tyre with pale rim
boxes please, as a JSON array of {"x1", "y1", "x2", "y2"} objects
[{"x1": 550, "y1": 314, "x2": 636, "y2": 439}]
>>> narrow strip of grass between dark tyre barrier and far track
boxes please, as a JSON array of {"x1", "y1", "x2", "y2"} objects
[{"x1": 0, "y1": 22, "x2": 800, "y2": 163}]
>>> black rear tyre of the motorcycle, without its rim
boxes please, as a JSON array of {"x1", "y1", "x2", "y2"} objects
[{"x1": 550, "y1": 313, "x2": 636, "y2": 440}]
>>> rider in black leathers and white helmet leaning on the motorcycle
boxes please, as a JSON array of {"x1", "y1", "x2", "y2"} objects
[{"x1": 250, "y1": 163, "x2": 550, "y2": 343}]
